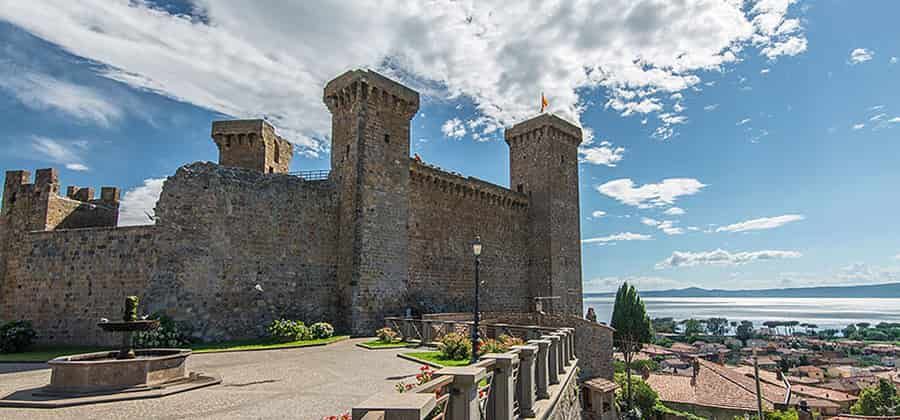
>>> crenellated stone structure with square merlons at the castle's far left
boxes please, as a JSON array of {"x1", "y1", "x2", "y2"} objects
[{"x1": 2, "y1": 168, "x2": 120, "y2": 231}]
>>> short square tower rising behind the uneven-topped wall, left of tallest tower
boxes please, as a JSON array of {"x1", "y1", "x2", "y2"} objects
[{"x1": 212, "y1": 120, "x2": 294, "y2": 174}]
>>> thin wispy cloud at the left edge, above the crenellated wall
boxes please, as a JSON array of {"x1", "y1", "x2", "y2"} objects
[{"x1": 0, "y1": 71, "x2": 122, "y2": 126}]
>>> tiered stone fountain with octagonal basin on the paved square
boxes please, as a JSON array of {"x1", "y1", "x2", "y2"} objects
[{"x1": 0, "y1": 296, "x2": 221, "y2": 408}]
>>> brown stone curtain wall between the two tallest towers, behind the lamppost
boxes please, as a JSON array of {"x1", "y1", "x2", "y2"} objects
[{"x1": 408, "y1": 161, "x2": 532, "y2": 313}]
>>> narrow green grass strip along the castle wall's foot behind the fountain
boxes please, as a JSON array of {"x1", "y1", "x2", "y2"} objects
[{"x1": 0, "y1": 335, "x2": 349, "y2": 363}]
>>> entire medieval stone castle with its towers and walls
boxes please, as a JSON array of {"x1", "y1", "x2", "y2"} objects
[{"x1": 0, "y1": 70, "x2": 582, "y2": 344}]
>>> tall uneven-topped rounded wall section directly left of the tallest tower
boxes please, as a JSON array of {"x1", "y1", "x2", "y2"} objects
[{"x1": 146, "y1": 163, "x2": 339, "y2": 340}]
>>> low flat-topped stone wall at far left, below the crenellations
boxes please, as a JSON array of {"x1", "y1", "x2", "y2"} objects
[{"x1": 0, "y1": 226, "x2": 157, "y2": 345}]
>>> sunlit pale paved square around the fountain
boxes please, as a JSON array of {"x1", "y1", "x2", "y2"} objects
[{"x1": 0, "y1": 339, "x2": 418, "y2": 420}]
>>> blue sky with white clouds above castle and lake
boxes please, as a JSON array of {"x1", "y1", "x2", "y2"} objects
[{"x1": 0, "y1": 0, "x2": 900, "y2": 292}]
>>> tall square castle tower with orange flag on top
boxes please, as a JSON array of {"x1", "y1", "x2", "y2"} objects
[{"x1": 505, "y1": 114, "x2": 582, "y2": 316}]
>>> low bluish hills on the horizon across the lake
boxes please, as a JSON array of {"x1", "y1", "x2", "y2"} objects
[{"x1": 584, "y1": 283, "x2": 900, "y2": 298}]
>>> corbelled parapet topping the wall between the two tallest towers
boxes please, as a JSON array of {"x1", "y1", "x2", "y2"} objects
[{"x1": 409, "y1": 159, "x2": 528, "y2": 210}]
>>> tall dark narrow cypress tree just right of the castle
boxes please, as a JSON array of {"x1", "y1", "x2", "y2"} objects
[{"x1": 610, "y1": 283, "x2": 653, "y2": 410}]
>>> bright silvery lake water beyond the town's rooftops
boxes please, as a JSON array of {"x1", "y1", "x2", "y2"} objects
[{"x1": 583, "y1": 296, "x2": 900, "y2": 329}]
